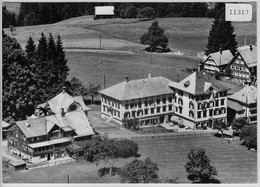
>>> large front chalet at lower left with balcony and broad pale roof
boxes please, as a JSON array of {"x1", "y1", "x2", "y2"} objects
[{"x1": 7, "y1": 110, "x2": 95, "y2": 163}]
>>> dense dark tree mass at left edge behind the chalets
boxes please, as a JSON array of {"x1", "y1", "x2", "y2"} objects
[{"x1": 2, "y1": 31, "x2": 97, "y2": 122}]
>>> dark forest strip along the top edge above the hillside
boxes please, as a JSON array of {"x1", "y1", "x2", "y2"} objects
[{"x1": 2, "y1": 3, "x2": 222, "y2": 28}]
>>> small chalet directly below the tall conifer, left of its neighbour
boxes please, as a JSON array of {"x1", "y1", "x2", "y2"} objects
[{"x1": 203, "y1": 49, "x2": 233, "y2": 73}]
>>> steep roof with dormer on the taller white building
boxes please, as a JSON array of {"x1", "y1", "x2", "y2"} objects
[{"x1": 169, "y1": 71, "x2": 227, "y2": 95}]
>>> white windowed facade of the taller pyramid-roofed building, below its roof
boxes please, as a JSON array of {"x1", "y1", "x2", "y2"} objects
[{"x1": 174, "y1": 89, "x2": 227, "y2": 129}]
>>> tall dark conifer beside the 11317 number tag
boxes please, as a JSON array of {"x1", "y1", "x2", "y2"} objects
[{"x1": 205, "y1": 3, "x2": 238, "y2": 55}]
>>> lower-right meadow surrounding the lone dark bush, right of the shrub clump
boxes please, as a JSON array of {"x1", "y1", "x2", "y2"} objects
[{"x1": 137, "y1": 136, "x2": 257, "y2": 183}]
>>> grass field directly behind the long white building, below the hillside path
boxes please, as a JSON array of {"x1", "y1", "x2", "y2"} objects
[{"x1": 66, "y1": 50, "x2": 242, "y2": 92}]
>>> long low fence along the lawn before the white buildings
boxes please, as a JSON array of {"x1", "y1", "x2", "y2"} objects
[{"x1": 115, "y1": 133, "x2": 212, "y2": 141}]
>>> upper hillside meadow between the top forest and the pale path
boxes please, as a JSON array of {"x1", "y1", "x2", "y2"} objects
[{"x1": 6, "y1": 16, "x2": 256, "y2": 56}]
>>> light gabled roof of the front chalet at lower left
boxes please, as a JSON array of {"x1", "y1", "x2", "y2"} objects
[{"x1": 16, "y1": 110, "x2": 95, "y2": 138}]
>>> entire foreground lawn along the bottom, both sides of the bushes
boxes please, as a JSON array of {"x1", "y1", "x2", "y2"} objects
[{"x1": 3, "y1": 136, "x2": 257, "y2": 183}]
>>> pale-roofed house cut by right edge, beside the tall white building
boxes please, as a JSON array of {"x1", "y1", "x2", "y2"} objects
[{"x1": 227, "y1": 85, "x2": 257, "y2": 123}]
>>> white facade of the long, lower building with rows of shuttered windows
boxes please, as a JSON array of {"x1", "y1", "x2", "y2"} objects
[{"x1": 101, "y1": 94, "x2": 174, "y2": 125}]
